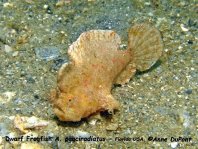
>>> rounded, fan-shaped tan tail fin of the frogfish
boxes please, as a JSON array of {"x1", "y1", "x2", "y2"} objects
[{"x1": 128, "y1": 23, "x2": 163, "y2": 71}]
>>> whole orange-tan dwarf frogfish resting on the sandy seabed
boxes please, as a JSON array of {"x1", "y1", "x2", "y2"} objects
[{"x1": 50, "y1": 24, "x2": 163, "y2": 121}]
